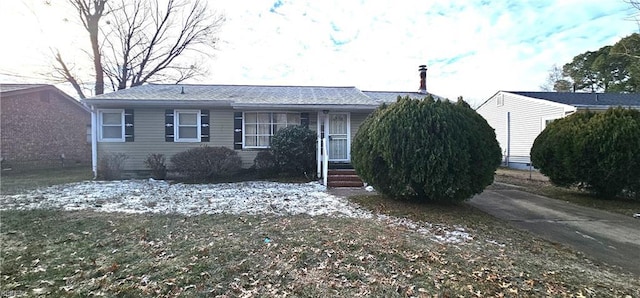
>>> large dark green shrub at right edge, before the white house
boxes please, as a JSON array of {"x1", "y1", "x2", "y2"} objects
[{"x1": 531, "y1": 108, "x2": 640, "y2": 198}]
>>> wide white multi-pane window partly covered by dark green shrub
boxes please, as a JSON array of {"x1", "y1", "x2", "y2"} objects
[{"x1": 243, "y1": 112, "x2": 300, "y2": 148}]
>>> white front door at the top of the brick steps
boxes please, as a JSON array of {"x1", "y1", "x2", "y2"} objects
[{"x1": 327, "y1": 113, "x2": 350, "y2": 162}]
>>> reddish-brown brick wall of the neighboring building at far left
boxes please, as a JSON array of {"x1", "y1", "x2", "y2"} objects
[{"x1": 0, "y1": 87, "x2": 91, "y2": 168}]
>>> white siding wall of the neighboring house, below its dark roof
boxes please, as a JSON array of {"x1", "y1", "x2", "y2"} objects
[{"x1": 477, "y1": 92, "x2": 565, "y2": 163}]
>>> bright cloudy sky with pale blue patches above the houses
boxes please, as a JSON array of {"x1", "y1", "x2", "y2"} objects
[{"x1": 0, "y1": 0, "x2": 640, "y2": 105}]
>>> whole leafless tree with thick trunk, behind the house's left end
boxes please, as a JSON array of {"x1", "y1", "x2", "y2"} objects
[{"x1": 56, "y1": 0, "x2": 224, "y2": 98}]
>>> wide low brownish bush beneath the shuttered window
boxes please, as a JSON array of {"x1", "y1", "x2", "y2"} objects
[{"x1": 171, "y1": 146, "x2": 242, "y2": 180}]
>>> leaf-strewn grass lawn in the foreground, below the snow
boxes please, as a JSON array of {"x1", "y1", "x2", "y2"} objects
[{"x1": 0, "y1": 207, "x2": 640, "y2": 297}]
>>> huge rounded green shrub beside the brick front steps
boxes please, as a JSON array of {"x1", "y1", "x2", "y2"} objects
[{"x1": 351, "y1": 97, "x2": 502, "y2": 201}]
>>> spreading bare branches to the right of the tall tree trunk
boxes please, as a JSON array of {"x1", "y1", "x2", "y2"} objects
[{"x1": 104, "y1": 0, "x2": 224, "y2": 89}]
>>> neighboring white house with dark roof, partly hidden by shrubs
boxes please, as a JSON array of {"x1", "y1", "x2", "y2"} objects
[{"x1": 476, "y1": 91, "x2": 640, "y2": 168}]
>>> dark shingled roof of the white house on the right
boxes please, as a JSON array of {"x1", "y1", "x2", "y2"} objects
[{"x1": 506, "y1": 91, "x2": 640, "y2": 108}]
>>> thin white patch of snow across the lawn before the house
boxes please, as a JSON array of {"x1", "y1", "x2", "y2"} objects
[{"x1": 0, "y1": 179, "x2": 473, "y2": 244}]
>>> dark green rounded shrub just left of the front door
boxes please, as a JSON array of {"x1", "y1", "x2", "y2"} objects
[{"x1": 271, "y1": 125, "x2": 317, "y2": 178}]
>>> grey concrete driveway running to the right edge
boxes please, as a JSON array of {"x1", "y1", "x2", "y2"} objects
[{"x1": 469, "y1": 185, "x2": 640, "y2": 276}]
